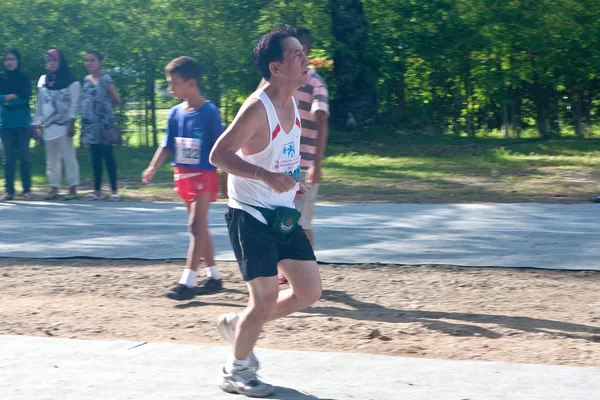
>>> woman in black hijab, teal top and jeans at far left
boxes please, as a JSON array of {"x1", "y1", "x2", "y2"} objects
[{"x1": 0, "y1": 49, "x2": 31, "y2": 201}]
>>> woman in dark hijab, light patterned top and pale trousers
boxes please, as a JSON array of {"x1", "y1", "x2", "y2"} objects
[{"x1": 34, "y1": 49, "x2": 81, "y2": 200}]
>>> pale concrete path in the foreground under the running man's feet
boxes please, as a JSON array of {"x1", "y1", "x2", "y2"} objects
[{"x1": 0, "y1": 336, "x2": 600, "y2": 400}]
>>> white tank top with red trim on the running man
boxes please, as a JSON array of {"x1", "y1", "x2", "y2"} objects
[{"x1": 227, "y1": 89, "x2": 302, "y2": 224}]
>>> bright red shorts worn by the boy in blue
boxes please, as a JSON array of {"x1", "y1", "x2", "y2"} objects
[{"x1": 173, "y1": 167, "x2": 219, "y2": 203}]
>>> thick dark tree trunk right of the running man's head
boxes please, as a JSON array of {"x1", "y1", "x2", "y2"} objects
[{"x1": 329, "y1": 0, "x2": 377, "y2": 125}]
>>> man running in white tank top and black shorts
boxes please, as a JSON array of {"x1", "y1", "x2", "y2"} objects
[{"x1": 210, "y1": 27, "x2": 322, "y2": 397}]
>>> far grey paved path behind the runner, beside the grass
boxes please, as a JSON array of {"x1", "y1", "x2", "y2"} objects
[{"x1": 0, "y1": 201, "x2": 600, "y2": 270}]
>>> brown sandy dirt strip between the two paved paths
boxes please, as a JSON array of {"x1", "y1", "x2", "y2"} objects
[{"x1": 0, "y1": 259, "x2": 600, "y2": 367}]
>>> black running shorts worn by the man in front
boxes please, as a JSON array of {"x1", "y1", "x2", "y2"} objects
[{"x1": 225, "y1": 207, "x2": 316, "y2": 282}]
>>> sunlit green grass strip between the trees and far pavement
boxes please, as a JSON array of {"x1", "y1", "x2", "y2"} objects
[{"x1": 0, "y1": 127, "x2": 600, "y2": 203}]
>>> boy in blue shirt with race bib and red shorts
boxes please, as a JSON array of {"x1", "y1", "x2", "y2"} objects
[{"x1": 142, "y1": 57, "x2": 223, "y2": 301}]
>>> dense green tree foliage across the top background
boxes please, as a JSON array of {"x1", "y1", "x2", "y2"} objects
[{"x1": 0, "y1": 0, "x2": 600, "y2": 141}]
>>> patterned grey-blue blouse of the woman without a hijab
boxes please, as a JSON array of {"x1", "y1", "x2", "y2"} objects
[{"x1": 81, "y1": 74, "x2": 115, "y2": 145}]
